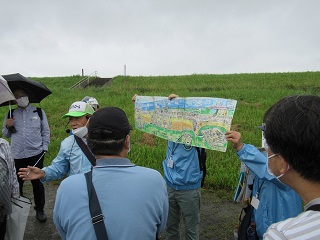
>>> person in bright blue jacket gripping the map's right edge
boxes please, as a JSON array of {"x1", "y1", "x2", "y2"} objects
[{"x1": 225, "y1": 131, "x2": 302, "y2": 239}]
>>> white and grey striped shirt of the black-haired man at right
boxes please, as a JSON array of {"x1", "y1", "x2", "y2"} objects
[{"x1": 263, "y1": 210, "x2": 320, "y2": 240}]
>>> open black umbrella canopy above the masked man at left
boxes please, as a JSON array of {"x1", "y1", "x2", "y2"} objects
[{"x1": 2, "y1": 73, "x2": 52, "y2": 106}]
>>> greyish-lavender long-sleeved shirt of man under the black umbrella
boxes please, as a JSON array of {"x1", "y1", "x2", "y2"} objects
[{"x1": 2, "y1": 105, "x2": 50, "y2": 159}]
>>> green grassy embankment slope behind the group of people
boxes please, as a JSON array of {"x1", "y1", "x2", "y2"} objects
[{"x1": 0, "y1": 72, "x2": 320, "y2": 190}]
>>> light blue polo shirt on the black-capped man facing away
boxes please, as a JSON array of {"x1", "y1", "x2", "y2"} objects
[{"x1": 53, "y1": 158, "x2": 168, "y2": 240}]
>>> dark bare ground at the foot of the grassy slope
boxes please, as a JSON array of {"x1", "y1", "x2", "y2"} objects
[{"x1": 24, "y1": 182, "x2": 243, "y2": 240}]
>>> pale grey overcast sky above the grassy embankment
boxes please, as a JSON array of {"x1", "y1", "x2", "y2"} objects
[{"x1": 0, "y1": 0, "x2": 320, "y2": 77}]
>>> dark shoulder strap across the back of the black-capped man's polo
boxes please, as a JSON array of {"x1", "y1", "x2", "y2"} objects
[{"x1": 84, "y1": 171, "x2": 108, "y2": 240}]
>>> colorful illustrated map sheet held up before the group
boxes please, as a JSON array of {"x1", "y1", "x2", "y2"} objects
[{"x1": 135, "y1": 96, "x2": 237, "y2": 152}]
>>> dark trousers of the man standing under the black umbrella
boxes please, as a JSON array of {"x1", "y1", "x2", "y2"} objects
[{"x1": 14, "y1": 152, "x2": 45, "y2": 211}]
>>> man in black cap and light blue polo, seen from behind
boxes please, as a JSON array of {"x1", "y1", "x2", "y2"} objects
[{"x1": 53, "y1": 107, "x2": 168, "y2": 240}]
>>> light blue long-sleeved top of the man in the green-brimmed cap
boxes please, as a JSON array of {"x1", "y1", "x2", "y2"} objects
[{"x1": 40, "y1": 135, "x2": 91, "y2": 182}]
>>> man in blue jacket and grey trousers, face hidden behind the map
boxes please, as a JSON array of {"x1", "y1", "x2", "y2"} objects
[{"x1": 132, "y1": 94, "x2": 203, "y2": 240}]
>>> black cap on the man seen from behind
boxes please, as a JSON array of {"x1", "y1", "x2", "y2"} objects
[{"x1": 88, "y1": 107, "x2": 132, "y2": 140}]
